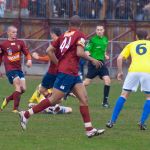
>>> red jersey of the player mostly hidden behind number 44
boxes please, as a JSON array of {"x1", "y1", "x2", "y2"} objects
[{"x1": 48, "y1": 47, "x2": 61, "y2": 74}]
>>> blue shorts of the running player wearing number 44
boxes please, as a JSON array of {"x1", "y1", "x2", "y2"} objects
[{"x1": 54, "y1": 73, "x2": 82, "y2": 93}]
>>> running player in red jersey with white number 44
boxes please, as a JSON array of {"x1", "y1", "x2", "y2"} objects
[{"x1": 19, "y1": 15, "x2": 105, "y2": 137}]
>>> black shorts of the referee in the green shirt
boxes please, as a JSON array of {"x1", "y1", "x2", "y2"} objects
[{"x1": 86, "y1": 62, "x2": 109, "y2": 79}]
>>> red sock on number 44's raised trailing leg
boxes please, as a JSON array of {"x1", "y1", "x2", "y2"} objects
[{"x1": 24, "y1": 99, "x2": 51, "y2": 119}]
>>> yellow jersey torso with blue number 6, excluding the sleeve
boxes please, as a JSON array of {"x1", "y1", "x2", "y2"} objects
[{"x1": 128, "y1": 40, "x2": 150, "y2": 73}]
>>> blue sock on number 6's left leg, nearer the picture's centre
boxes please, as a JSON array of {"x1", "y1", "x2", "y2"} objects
[{"x1": 111, "y1": 96, "x2": 126, "y2": 122}]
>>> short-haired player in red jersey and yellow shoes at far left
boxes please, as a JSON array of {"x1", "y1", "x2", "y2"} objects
[{"x1": 0, "y1": 26, "x2": 32, "y2": 112}]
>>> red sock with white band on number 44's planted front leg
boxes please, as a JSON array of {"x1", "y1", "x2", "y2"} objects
[{"x1": 80, "y1": 106, "x2": 93, "y2": 131}]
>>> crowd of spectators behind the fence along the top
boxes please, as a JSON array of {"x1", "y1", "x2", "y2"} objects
[{"x1": 0, "y1": 0, "x2": 150, "y2": 21}]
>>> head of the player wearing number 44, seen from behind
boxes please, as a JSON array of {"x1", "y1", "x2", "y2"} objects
[{"x1": 69, "y1": 15, "x2": 81, "y2": 28}]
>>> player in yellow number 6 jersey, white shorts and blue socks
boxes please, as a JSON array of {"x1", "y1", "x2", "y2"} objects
[{"x1": 106, "y1": 30, "x2": 150, "y2": 130}]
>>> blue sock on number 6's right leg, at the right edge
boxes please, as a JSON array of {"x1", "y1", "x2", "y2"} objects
[{"x1": 140, "y1": 100, "x2": 150, "y2": 124}]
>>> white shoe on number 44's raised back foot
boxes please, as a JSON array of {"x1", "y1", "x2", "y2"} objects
[{"x1": 19, "y1": 111, "x2": 28, "y2": 130}]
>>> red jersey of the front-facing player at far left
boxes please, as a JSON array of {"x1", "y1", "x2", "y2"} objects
[{"x1": 0, "y1": 39, "x2": 31, "y2": 72}]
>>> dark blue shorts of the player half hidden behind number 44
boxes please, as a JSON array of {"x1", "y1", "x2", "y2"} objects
[{"x1": 41, "y1": 72, "x2": 57, "y2": 89}]
